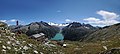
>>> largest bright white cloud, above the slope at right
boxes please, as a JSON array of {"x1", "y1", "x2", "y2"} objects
[{"x1": 83, "y1": 10, "x2": 119, "y2": 26}]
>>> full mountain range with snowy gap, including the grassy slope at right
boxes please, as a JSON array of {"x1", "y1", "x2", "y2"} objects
[{"x1": 4, "y1": 21, "x2": 120, "y2": 41}]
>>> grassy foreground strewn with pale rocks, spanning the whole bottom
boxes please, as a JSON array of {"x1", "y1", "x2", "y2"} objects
[{"x1": 0, "y1": 30, "x2": 120, "y2": 54}]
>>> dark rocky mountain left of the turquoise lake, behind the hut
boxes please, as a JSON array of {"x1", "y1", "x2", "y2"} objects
[{"x1": 9, "y1": 21, "x2": 59, "y2": 39}]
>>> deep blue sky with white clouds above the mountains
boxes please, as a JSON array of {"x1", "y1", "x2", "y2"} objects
[{"x1": 0, "y1": 0, "x2": 120, "y2": 26}]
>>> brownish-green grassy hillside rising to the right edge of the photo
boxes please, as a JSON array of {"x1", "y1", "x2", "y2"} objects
[{"x1": 84, "y1": 23, "x2": 120, "y2": 41}]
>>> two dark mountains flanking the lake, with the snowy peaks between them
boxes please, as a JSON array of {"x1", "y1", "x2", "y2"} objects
[{"x1": 9, "y1": 21, "x2": 98, "y2": 40}]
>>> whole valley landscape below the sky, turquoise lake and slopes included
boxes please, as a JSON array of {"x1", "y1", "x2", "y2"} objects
[{"x1": 0, "y1": 22, "x2": 120, "y2": 54}]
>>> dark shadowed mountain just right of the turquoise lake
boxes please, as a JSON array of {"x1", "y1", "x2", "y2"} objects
[{"x1": 62, "y1": 22, "x2": 97, "y2": 41}]
